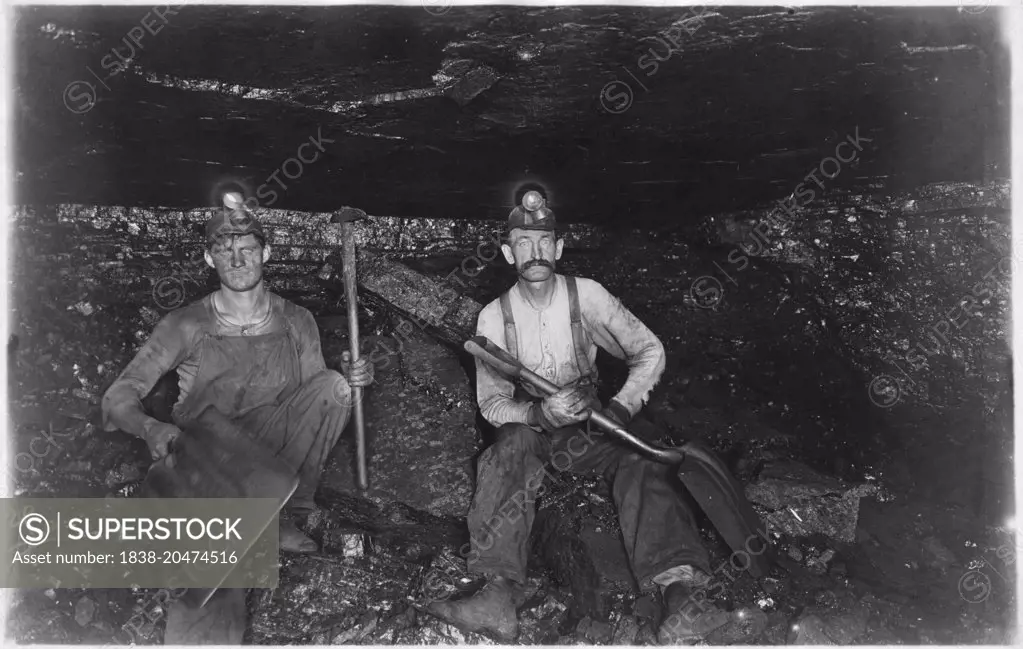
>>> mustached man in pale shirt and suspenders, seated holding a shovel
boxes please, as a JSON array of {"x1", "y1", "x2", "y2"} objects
[{"x1": 429, "y1": 192, "x2": 744, "y2": 644}]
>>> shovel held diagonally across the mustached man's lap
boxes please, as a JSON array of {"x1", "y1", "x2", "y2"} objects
[{"x1": 464, "y1": 336, "x2": 773, "y2": 578}]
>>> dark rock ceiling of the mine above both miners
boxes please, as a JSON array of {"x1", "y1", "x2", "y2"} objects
[{"x1": 14, "y1": 0, "x2": 1010, "y2": 225}]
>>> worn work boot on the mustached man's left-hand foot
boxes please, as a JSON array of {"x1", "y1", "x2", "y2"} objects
[{"x1": 427, "y1": 577, "x2": 519, "y2": 643}]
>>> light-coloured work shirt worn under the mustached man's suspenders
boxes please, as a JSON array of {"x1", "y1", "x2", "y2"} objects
[{"x1": 476, "y1": 274, "x2": 665, "y2": 426}]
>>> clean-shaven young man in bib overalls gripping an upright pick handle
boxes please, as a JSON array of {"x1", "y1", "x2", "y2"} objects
[{"x1": 102, "y1": 200, "x2": 373, "y2": 642}]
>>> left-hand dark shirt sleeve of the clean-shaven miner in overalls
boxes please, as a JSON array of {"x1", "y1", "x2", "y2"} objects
[{"x1": 102, "y1": 311, "x2": 195, "y2": 437}]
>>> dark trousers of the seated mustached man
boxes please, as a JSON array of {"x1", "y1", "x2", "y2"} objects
[{"x1": 468, "y1": 424, "x2": 710, "y2": 589}]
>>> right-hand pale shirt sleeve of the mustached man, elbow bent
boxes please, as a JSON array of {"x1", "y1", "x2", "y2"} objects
[{"x1": 577, "y1": 278, "x2": 666, "y2": 416}]
